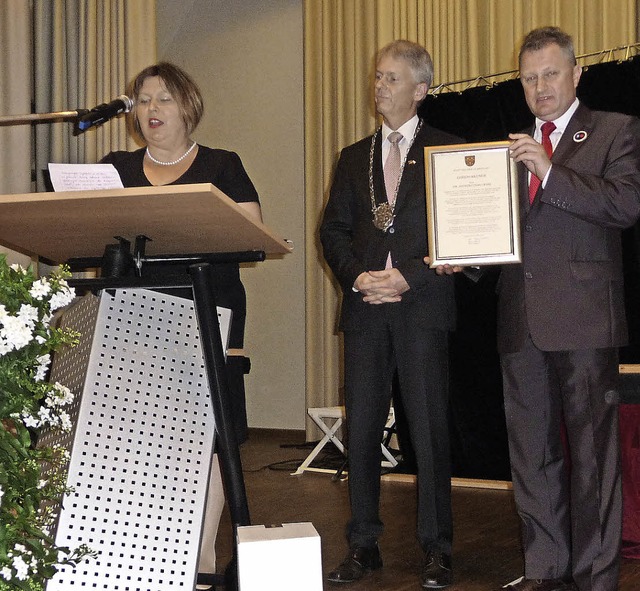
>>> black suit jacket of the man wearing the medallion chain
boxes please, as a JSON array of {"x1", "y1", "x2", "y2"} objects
[{"x1": 320, "y1": 125, "x2": 462, "y2": 330}]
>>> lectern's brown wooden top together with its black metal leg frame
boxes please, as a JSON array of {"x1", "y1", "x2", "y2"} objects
[{"x1": 0, "y1": 183, "x2": 292, "y2": 588}]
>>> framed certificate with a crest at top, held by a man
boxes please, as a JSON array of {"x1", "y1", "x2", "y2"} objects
[{"x1": 424, "y1": 141, "x2": 521, "y2": 267}]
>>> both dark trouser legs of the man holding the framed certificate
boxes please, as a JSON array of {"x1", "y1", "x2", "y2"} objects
[{"x1": 502, "y1": 342, "x2": 621, "y2": 591}]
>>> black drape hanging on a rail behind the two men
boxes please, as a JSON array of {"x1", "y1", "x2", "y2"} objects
[{"x1": 410, "y1": 56, "x2": 640, "y2": 480}]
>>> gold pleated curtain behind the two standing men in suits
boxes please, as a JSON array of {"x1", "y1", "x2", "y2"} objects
[{"x1": 304, "y1": 0, "x2": 638, "y2": 434}]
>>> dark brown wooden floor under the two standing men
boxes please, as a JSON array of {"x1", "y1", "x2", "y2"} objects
[{"x1": 217, "y1": 430, "x2": 640, "y2": 591}]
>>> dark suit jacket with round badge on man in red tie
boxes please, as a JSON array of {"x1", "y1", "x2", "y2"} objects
[{"x1": 497, "y1": 105, "x2": 640, "y2": 353}]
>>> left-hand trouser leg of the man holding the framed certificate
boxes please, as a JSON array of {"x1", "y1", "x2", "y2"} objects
[{"x1": 502, "y1": 340, "x2": 571, "y2": 579}]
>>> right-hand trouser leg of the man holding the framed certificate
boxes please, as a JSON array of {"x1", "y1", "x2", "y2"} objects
[{"x1": 551, "y1": 349, "x2": 622, "y2": 591}]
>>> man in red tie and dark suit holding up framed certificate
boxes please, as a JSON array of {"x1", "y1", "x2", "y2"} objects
[{"x1": 497, "y1": 27, "x2": 640, "y2": 591}]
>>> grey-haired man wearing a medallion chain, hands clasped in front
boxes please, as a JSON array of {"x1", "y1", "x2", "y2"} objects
[{"x1": 320, "y1": 40, "x2": 461, "y2": 588}]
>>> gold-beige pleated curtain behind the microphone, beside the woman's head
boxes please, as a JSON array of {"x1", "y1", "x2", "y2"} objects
[{"x1": 33, "y1": 0, "x2": 156, "y2": 190}]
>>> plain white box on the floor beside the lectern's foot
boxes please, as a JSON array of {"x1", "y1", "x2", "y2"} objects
[{"x1": 237, "y1": 522, "x2": 322, "y2": 591}]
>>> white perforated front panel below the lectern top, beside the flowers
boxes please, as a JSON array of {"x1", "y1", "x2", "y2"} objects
[{"x1": 42, "y1": 289, "x2": 230, "y2": 591}]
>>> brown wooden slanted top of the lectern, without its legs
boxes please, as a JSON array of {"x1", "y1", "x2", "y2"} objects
[{"x1": 0, "y1": 183, "x2": 292, "y2": 263}]
